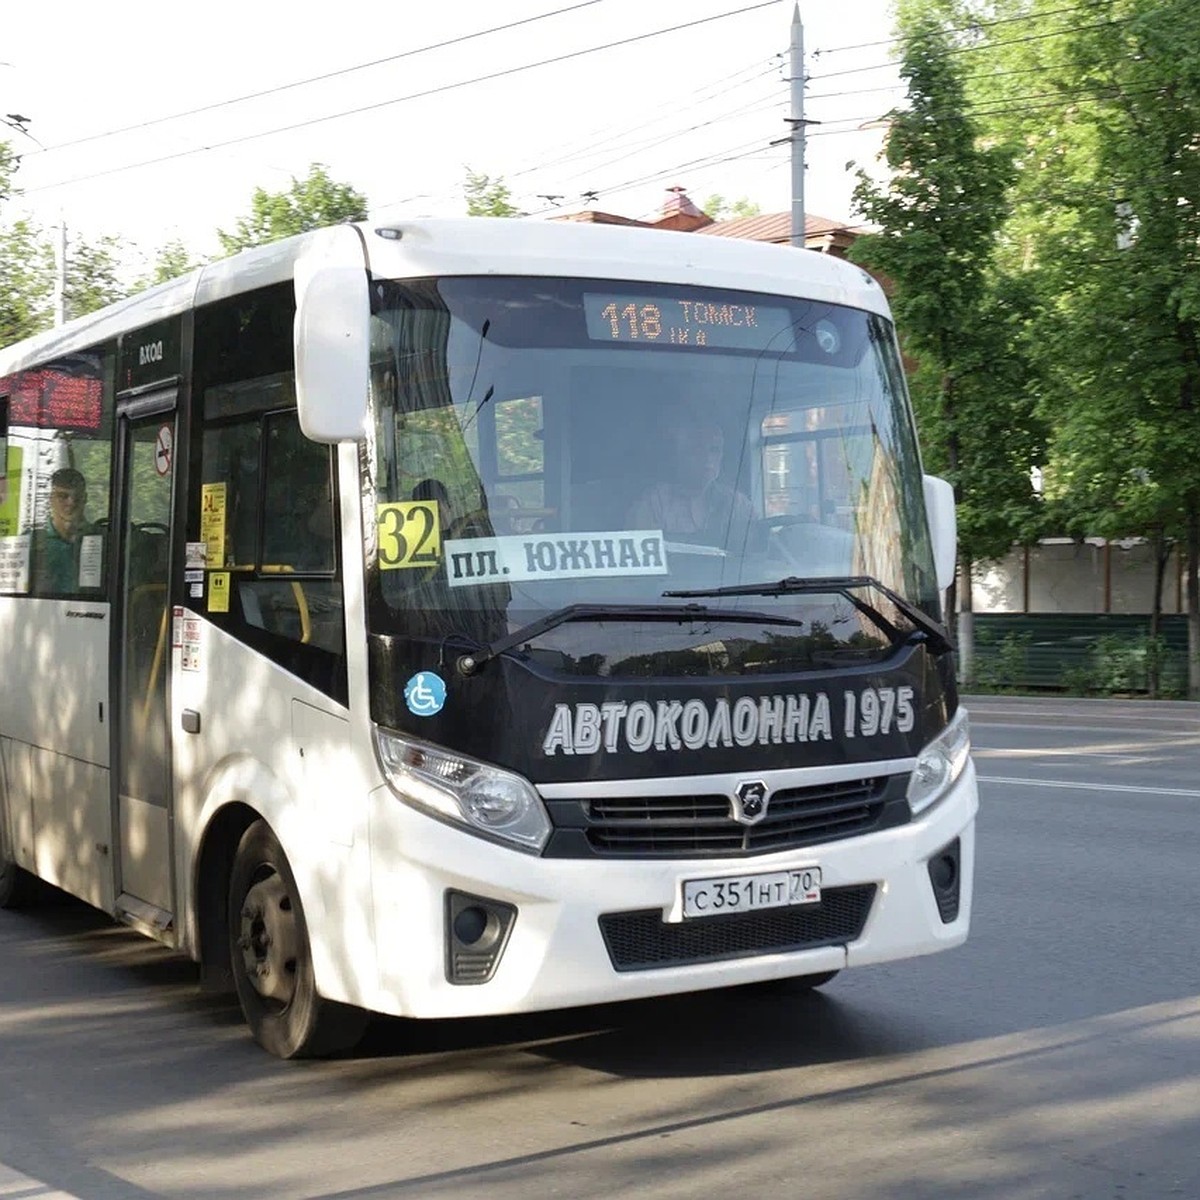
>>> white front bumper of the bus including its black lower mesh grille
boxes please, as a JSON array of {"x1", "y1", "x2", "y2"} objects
[{"x1": 361, "y1": 763, "x2": 978, "y2": 1018}]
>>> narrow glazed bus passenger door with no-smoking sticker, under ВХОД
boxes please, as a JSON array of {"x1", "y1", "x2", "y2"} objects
[{"x1": 112, "y1": 398, "x2": 175, "y2": 941}]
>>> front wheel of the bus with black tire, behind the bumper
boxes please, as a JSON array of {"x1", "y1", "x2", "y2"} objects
[{"x1": 229, "y1": 821, "x2": 368, "y2": 1058}]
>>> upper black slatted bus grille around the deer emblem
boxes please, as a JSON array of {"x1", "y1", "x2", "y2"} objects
[{"x1": 546, "y1": 775, "x2": 908, "y2": 858}]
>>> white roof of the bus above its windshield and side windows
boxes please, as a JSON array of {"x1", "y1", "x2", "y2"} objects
[{"x1": 0, "y1": 217, "x2": 888, "y2": 378}]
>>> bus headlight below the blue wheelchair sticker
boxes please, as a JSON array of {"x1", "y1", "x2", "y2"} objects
[{"x1": 376, "y1": 728, "x2": 550, "y2": 854}]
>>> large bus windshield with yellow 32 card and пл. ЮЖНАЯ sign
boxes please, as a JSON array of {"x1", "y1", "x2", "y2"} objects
[{"x1": 364, "y1": 277, "x2": 938, "y2": 674}]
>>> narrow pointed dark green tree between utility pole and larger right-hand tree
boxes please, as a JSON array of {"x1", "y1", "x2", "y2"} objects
[{"x1": 851, "y1": 5, "x2": 1043, "y2": 677}]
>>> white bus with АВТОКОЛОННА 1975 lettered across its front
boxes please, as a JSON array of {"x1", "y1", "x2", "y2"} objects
[{"x1": 0, "y1": 218, "x2": 977, "y2": 1057}]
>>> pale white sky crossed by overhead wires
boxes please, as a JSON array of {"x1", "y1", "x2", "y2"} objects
[{"x1": 0, "y1": 0, "x2": 902, "y2": 270}]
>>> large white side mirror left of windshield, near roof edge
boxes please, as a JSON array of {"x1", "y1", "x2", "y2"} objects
[{"x1": 293, "y1": 226, "x2": 371, "y2": 444}]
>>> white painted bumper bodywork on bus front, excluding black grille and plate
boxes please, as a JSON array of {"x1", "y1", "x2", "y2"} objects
[{"x1": 361, "y1": 764, "x2": 978, "y2": 1018}]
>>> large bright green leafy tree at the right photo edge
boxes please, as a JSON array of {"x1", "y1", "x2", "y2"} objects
[{"x1": 960, "y1": 0, "x2": 1200, "y2": 698}]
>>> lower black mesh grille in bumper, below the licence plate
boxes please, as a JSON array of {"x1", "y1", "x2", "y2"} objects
[{"x1": 600, "y1": 883, "x2": 875, "y2": 971}]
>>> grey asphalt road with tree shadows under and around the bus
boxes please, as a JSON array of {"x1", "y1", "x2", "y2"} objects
[{"x1": 0, "y1": 697, "x2": 1200, "y2": 1200}]
